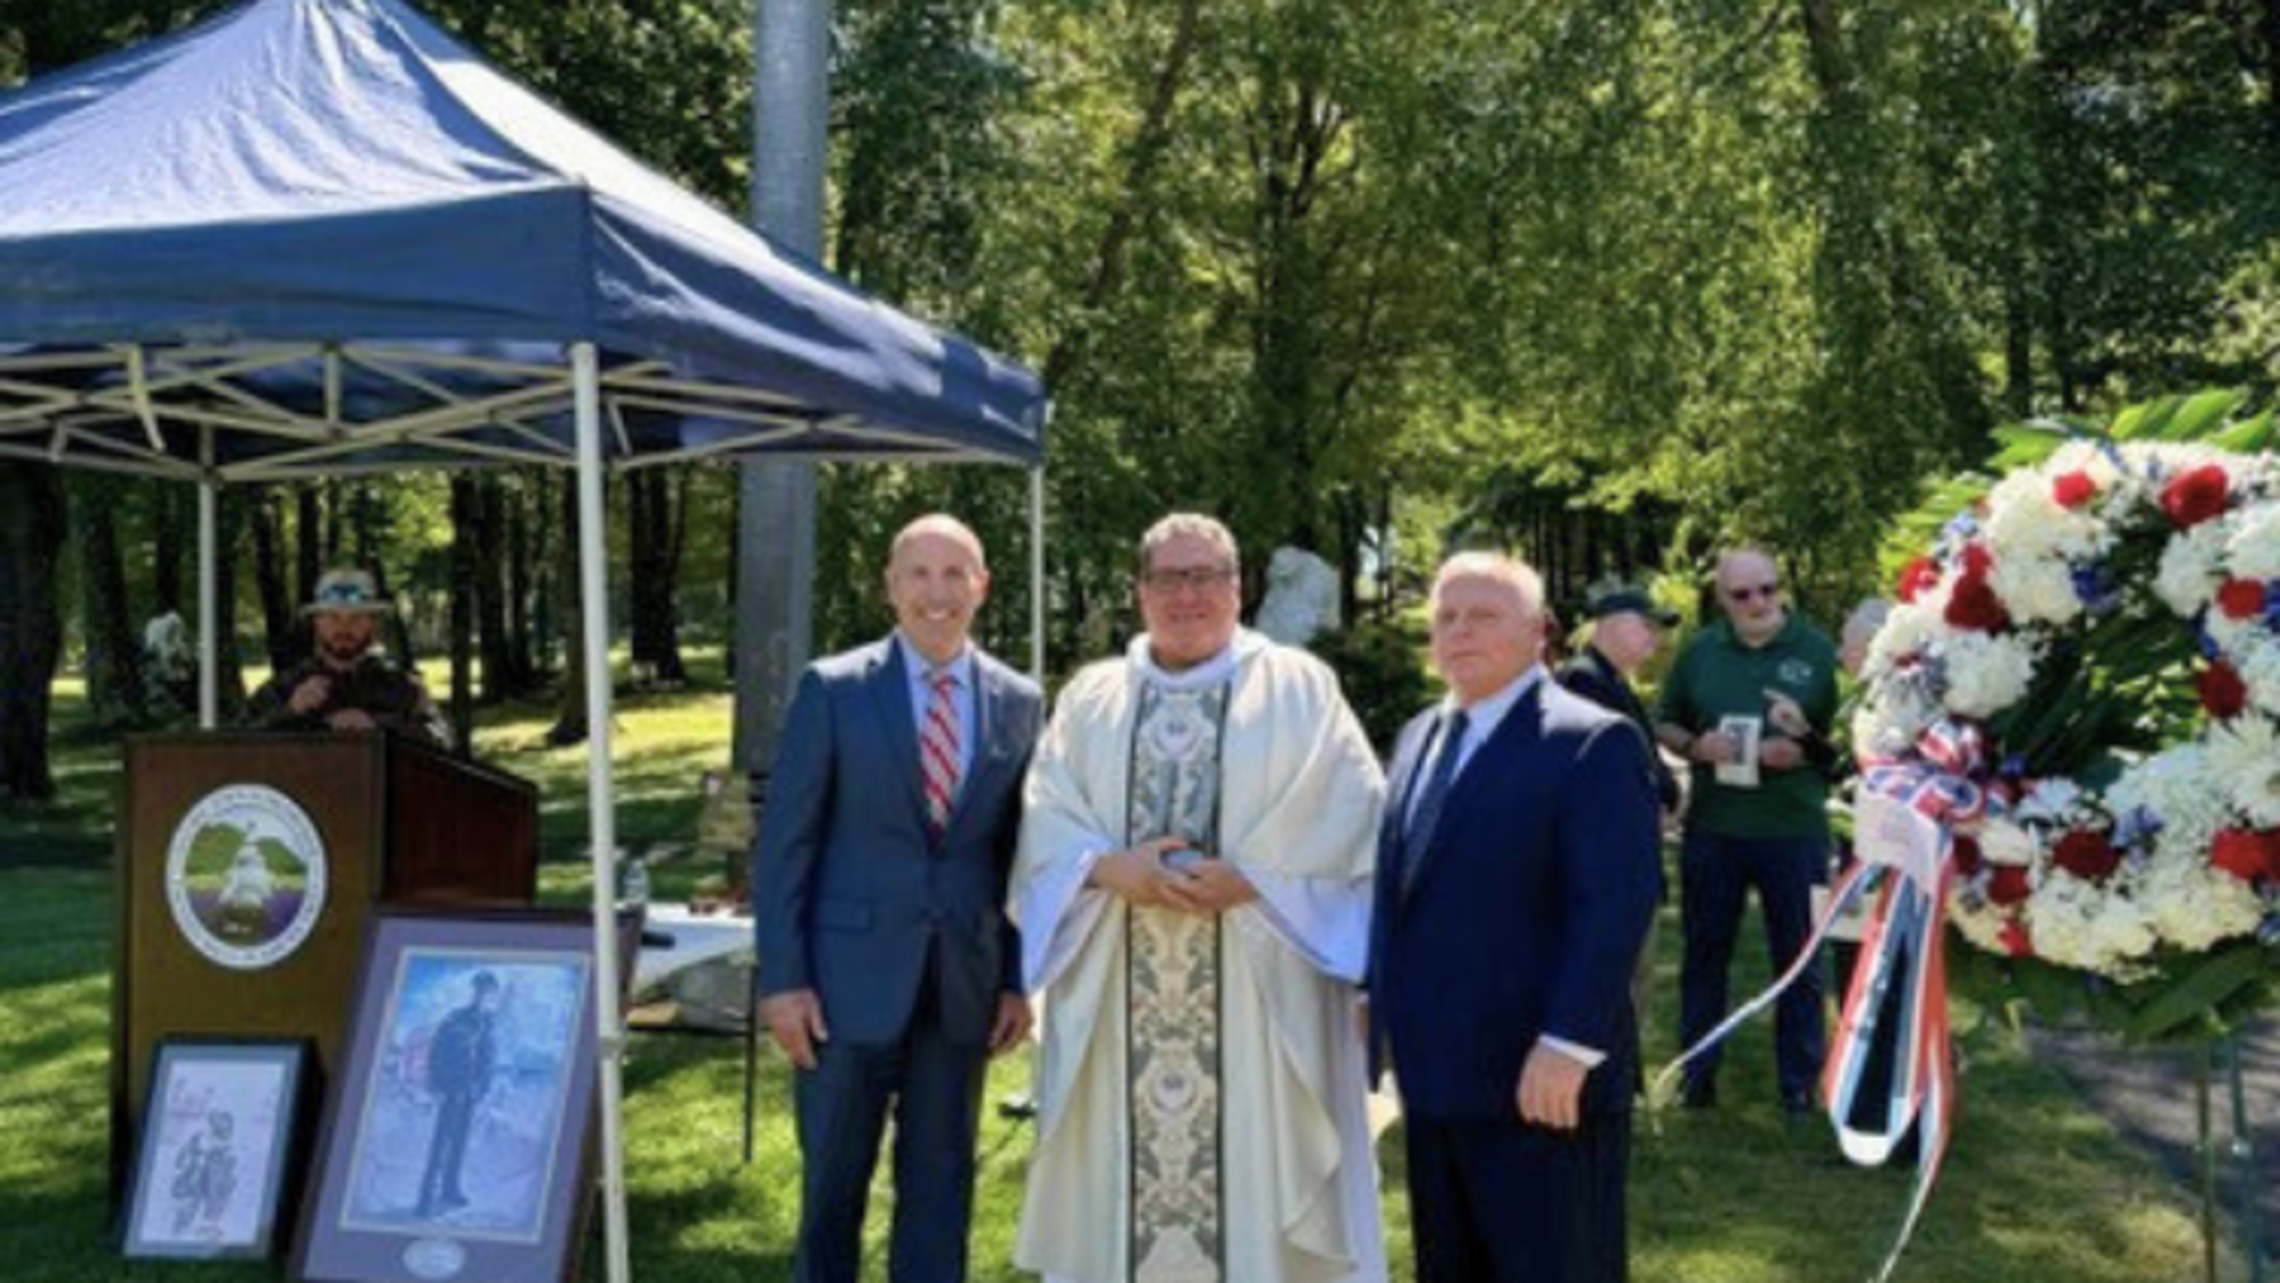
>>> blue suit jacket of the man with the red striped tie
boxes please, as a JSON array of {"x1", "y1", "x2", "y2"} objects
[{"x1": 752, "y1": 638, "x2": 1042, "y2": 1044}]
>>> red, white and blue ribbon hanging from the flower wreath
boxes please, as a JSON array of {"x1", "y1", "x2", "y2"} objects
[{"x1": 1653, "y1": 722, "x2": 1988, "y2": 1283}]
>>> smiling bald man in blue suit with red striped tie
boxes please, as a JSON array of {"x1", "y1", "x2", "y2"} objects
[{"x1": 752, "y1": 515, "x2": 1040, "y2": 1283}]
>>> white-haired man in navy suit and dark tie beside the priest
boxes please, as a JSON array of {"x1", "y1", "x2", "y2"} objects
[{"x1": 1370, "y1": 554, "x2": 1662, "y2": 1283}]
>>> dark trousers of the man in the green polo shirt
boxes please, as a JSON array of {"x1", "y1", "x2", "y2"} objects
[{"x1": 1678, "y1": 830, "x2": 1829, "y2": 1101}]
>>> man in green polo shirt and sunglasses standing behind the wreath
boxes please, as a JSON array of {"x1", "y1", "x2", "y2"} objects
[{"x1": 1655, "y1": 549, "x2": 1838, "y2": 1112}]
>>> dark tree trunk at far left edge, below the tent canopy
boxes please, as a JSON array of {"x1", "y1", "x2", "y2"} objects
[{"x1": 0, "y1": 460, "x2": 66, "y2": 804}]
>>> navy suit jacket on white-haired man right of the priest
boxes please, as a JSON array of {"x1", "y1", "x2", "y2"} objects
[{"x1": 1370, "y1": 679, "x2": 1662, "y2": 1119}]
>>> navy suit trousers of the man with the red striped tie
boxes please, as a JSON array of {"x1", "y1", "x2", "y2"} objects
[{"x1": 791, "y1": 966, "x2": 990, "y2": 1283}]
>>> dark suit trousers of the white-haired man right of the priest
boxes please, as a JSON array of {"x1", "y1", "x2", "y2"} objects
[{"x1": 1402, "y1": 1110, "x2": 1630, "y2": 1283}]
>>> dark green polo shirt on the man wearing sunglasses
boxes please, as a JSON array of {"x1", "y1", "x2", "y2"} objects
[{"x1": 1655, "y1": 613, "x2": 1838, "y2": 839}]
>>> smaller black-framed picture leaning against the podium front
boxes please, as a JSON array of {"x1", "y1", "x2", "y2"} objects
[{"x1": 119, "y1": 1039, "x2": 312, "y2": 1260}]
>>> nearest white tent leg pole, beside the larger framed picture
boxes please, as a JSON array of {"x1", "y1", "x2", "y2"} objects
[{"x1": 570, "y1": 342, "x2": 632, "y2": 1283}]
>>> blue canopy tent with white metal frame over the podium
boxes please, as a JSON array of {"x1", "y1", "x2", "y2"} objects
[{"x1": 0, "y1": 0, "x2": 1047, "y2": 1278}]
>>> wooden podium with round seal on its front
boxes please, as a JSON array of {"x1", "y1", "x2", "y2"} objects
[{"x1": 112, "y1": 732, "x2": 538, "y2": 1199}]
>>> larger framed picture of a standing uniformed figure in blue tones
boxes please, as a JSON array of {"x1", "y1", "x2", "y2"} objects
[{"x1": 294, "y1": 909, "x2": 638, "y2": 1283}]
